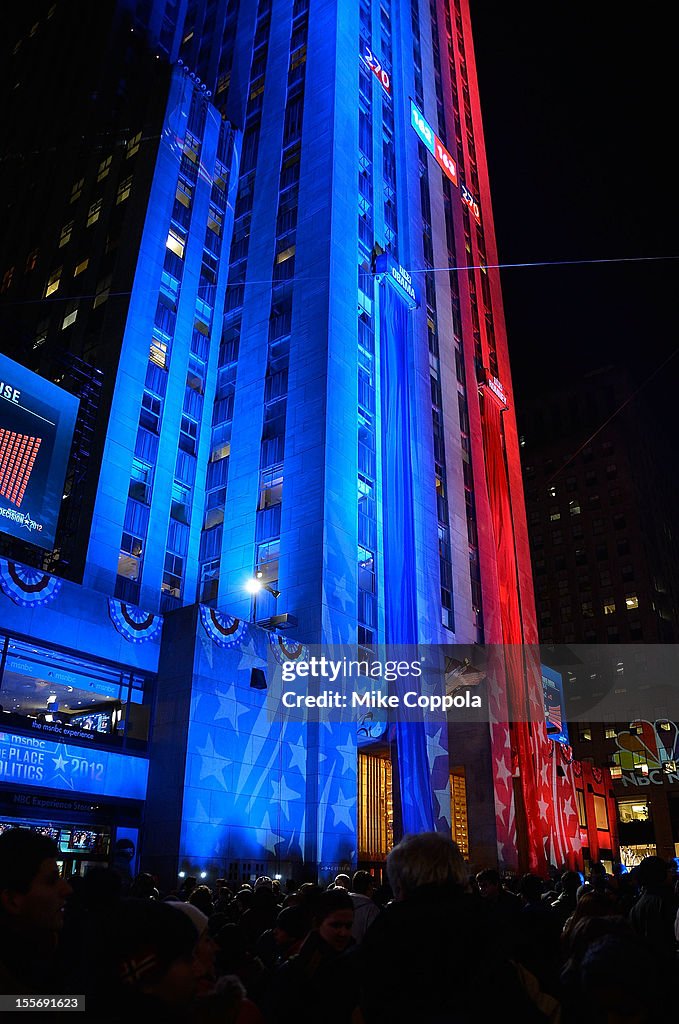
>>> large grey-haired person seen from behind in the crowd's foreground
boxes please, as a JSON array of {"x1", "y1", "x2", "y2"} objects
[{"x1": 354, "y1": 833, "x2": 548, "y2": 1024}]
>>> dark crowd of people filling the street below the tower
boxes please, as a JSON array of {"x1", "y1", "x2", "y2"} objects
[{"x1": 0, "y1": 828, "x2": 679, "y2": 1024}]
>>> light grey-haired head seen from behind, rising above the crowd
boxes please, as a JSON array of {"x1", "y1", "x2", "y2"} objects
[{"x1": 386, "y1": 833, "x2": 468, "y2": 900}]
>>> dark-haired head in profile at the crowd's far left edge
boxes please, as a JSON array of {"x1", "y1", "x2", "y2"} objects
[{"x1": 0, "y1": 828, "x2": 72, "y2": 937}]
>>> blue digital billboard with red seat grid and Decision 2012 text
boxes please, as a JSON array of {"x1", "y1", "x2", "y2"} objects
[{"x1": 0, "y1": 354, "x2": 80, "y2": 550}]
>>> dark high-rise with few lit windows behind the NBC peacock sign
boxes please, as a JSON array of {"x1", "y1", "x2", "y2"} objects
[{"x1": 519, "y1": 367, "x2": 679, "y2": 865}]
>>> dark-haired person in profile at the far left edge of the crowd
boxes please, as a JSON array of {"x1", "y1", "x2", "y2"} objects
[{"x1": 0, "y1": 828, "x2": 72, "y2": 994}]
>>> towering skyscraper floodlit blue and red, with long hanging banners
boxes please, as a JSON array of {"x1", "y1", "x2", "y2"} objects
[{"x1": 0, "y1": 0, "x2": 580, "y2": 881}]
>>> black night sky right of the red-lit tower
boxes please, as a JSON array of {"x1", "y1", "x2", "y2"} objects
[{"x1": 471, "y1": 0, "x2": 679, "y2": 406}]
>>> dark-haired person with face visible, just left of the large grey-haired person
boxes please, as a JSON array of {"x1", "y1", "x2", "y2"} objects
[{"x1": 263, "y1": 886, "x2": 357, "y2": 1024}]
